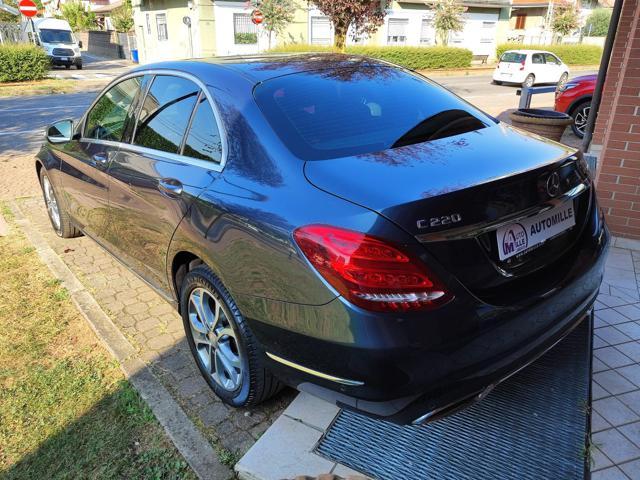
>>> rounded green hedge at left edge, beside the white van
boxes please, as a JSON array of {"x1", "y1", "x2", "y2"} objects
[{"x1": 0, "y1": 45, "x2": 49, "y2": 83}]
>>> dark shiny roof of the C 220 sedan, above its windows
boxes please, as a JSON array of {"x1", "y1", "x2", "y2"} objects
[{"x1": 132, "y1": 53, "x2": 400, "y2": 84}]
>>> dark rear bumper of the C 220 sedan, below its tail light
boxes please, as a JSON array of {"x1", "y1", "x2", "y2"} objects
[{"x1": 246, "y1": 194, "x2": 609, "y2": 423}]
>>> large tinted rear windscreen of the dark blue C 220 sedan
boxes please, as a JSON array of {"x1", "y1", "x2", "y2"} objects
[{"x1": 254, "y1": 66, "x2": 492, "y2": 160}]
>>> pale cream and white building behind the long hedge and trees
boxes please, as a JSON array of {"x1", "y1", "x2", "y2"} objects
[{"x1": 133, "y1": 0, "x2": 511, "y2": 62}]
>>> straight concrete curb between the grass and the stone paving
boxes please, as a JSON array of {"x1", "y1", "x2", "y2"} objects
[{"x1": 10, "y1": 200, "x2": 233, "y2": 480}]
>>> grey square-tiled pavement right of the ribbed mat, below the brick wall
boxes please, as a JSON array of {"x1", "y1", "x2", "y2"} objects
[{"x1": 591, "y1": 248, "x2": 640, "y2": 480}]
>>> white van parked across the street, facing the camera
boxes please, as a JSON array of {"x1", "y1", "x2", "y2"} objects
[{"x1": 23, "y1": 18, "x2": 82, "y2": 70}]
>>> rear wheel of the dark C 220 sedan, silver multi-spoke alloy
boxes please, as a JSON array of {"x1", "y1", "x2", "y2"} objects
[{"x1": 180, "y1": 265, "x2": 282, "y2": 407}]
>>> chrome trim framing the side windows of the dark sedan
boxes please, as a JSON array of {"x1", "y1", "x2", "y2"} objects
[{"x1": 80, "y1": 68, "x2": 228, "y2": 172}]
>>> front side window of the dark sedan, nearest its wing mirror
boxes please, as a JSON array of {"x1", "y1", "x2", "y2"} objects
[{"x1": 84, "y1": 76, "x2": 143, "y2": 142}]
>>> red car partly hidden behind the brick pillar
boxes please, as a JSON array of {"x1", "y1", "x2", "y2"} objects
[{"x1": 555, "y1": 75, "x2": 598, "y2": 138}]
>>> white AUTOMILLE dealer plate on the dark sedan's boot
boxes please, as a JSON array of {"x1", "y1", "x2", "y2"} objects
[{"x1": 496, "y1": 201, "x2": 576, "y2": 260}]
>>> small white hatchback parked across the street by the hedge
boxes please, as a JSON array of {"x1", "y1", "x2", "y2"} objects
[{"x1": 493, "y1": 50, "x2": 569, "y2": 87}]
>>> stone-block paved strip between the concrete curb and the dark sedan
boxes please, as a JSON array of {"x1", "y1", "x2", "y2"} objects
[{"x1": 18, "y1": 196, "x2": 294, "y2": 462}]
